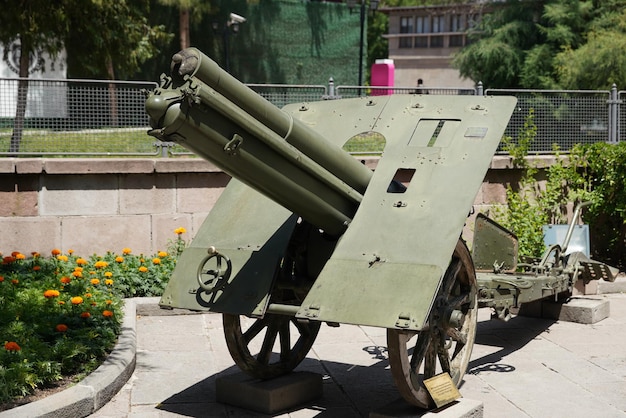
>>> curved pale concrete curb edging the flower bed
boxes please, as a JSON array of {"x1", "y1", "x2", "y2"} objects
[{"x1": 0, "y1": 299, "x2": 141, "y2": 418}]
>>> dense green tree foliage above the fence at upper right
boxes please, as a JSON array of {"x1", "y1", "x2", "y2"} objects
[{"x1": 454, "y1": 0, "x2": 626, "y2": 89}]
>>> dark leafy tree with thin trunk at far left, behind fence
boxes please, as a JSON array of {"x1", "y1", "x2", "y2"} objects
[{"x1": 0, "y1": 0, "x2": 69, "y2": 153}]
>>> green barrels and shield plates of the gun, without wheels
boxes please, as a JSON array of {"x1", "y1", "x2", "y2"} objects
[{"x1": 146, "y1": 50, "x2": 516, "y2": 330}]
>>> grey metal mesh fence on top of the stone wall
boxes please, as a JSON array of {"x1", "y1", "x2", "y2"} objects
[{"x1": 0, "y1": 78, "x2": 626, "y2": 157}]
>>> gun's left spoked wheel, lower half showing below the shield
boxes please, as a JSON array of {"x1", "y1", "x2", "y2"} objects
[{"x1": 223, "y1": 314, "x2": 320, "y2": 379}]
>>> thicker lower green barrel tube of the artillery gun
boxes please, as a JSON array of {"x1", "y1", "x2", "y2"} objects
[{"x1": 146, "y1": 53, "x2": 371, "y2": 235}]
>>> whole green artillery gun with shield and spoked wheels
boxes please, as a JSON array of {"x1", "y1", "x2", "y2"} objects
[{"x1": 146, "y1": 48, "x2": 616, "y2": 408}]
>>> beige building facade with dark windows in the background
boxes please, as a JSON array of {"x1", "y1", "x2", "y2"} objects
[{"x1": 378, "y1": 1, "x2": 490, "y2": 88}]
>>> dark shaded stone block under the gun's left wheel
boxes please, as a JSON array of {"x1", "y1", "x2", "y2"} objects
[{"x1": 215, "y1": 372, "x2": 322, "y2": 414}]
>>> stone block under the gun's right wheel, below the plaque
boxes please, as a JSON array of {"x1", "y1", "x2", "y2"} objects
[{"x1": 369, "y1": 398, "x2": 483, "y2": 418}]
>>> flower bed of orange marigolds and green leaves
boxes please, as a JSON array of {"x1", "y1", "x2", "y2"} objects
[{"x1": 0, "y1": 228, "x2": 186, "y2": 410}]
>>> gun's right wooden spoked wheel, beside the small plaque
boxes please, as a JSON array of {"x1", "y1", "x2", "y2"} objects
[{"x1": 387, "y1": 240, "x2": 478, "y2": 409}]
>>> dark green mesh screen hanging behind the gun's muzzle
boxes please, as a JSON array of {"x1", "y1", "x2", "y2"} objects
[{"x1": 192, "y1": 0, "x2": 360, "y2": 85}]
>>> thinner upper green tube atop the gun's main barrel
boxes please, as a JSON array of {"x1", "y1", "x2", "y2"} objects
[{"x1": 172, "y1": 48, "x2": 372, "y2": 193}]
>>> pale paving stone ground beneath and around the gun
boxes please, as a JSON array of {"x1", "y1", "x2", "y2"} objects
[{"x1": 92, "y1": 294, "x2": 626, "y2": 418}]
